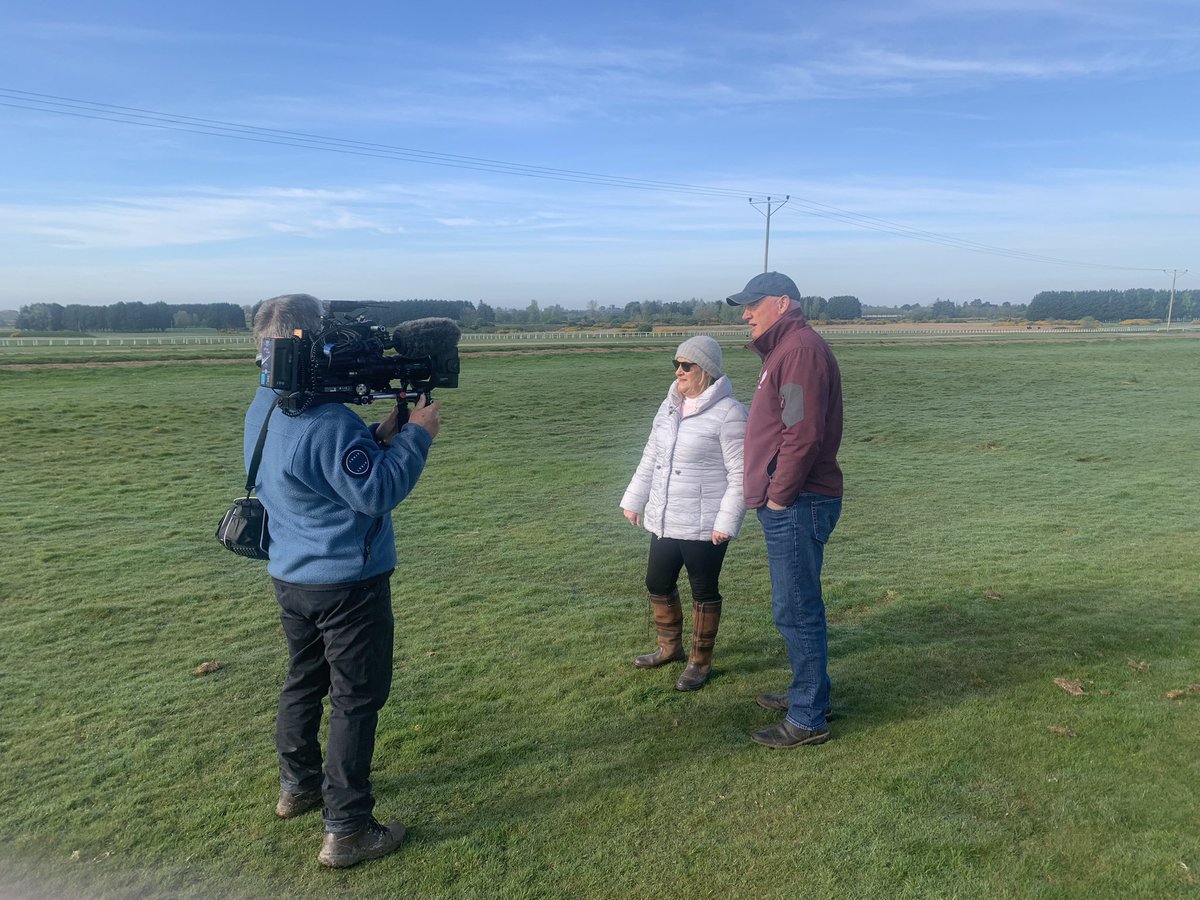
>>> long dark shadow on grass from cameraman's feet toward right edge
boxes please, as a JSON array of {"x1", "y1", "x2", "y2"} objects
[{"x1": 367, "y1": 586, "x2": 1200, "y2": 845}]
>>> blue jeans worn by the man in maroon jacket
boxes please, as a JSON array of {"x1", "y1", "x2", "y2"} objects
[{"x1": 758, "y1": 493, "x2": 841, "y2": 731}]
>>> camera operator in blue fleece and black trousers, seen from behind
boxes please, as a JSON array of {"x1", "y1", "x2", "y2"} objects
[{"x1": 245, "y1": 294, "x2": 440, "y2": 868}]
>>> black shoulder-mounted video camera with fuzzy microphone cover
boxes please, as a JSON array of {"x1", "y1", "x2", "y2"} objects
[{"x1": 259, "y1": 300, "x2": 462, "y2": 415}]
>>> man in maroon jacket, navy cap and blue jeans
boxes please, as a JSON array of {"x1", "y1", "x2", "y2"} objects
[{"x1": 726, "y1": 272, "x2": 841, "y2": 748}]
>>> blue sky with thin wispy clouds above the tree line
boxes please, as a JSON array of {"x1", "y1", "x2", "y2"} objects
[{"x1": 0, "y1": 0, "x2": 1200, "y2": 308}]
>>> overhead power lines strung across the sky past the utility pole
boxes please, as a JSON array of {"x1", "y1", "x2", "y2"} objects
[{"x1": 0, "y1": 88, "x2": 1180, "y2": 272}]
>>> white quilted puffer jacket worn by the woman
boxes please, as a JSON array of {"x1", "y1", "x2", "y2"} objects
[{"x1": 620, "y1": 376, "x2": 746, "y2": 541}]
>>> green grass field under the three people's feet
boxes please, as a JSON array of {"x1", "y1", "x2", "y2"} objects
[{"x1": 0, "y1": 337, "x2": 1200, "y2": 898}]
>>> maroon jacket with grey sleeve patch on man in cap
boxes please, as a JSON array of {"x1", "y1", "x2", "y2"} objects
[{"x1": 742, "y1": 310, "x2": 841, "y2": 509}]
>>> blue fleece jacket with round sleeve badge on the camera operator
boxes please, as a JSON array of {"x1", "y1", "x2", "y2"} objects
[{"x1": 244, "y1": 388, "x2": 433, "y2": 584}]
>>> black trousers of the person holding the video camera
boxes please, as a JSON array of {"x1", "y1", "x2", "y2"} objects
[{"x1": 275, "y1": 572, "x2": 395, "y2": 834}]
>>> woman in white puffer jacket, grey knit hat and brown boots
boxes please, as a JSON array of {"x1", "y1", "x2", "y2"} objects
[{"x1": 620, "y1": 335, "x2": 746, "y2": 691}]
